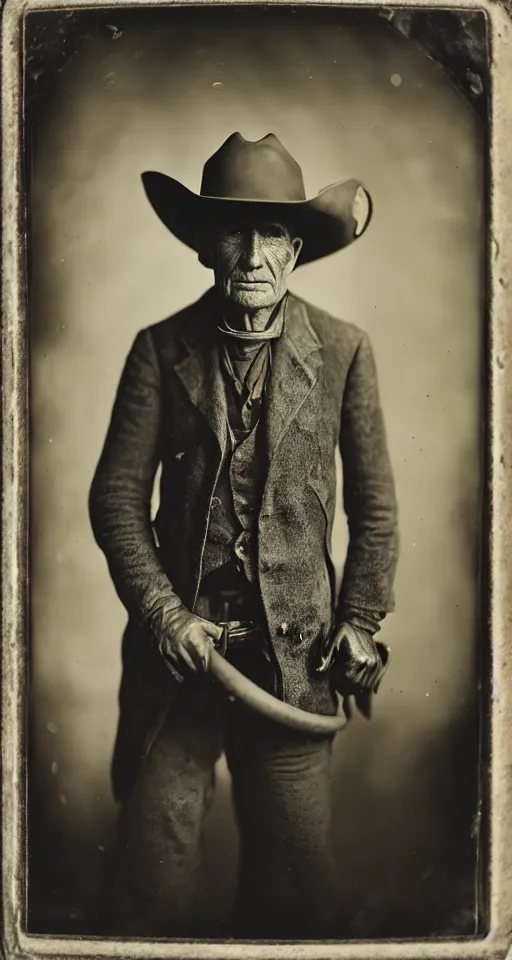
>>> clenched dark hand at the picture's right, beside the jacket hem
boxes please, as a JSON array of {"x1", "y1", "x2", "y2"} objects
[{"x1": 318, "y1": 623, "x2": 383, "y2": 693}]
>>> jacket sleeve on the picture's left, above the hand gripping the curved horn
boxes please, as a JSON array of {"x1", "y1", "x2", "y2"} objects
[{"x1": 89, "y1": 330, "x2": 181, "y2": 641}]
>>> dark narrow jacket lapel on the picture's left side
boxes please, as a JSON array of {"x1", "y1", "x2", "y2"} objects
[{"x1": 174, "y1": 298, "x2": 228, "y2": 453}]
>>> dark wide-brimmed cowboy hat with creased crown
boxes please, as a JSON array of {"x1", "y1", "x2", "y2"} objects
[{"x1": 142, "y1": 133, "x2": 372, "y2": 267}]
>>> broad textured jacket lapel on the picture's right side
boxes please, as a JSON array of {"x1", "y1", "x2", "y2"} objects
[{"x1": 265, "y1": 294, "x2": 322, "y2": 461}]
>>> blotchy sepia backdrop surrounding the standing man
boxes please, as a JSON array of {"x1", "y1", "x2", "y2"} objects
[{"x1": 27, "y1": 5, "x2": 484, "y2": 937}]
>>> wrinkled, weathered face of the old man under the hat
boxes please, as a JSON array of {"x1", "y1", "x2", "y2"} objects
[{"x1": 215, "y1": 223, "x2": 302, "y2": 312}]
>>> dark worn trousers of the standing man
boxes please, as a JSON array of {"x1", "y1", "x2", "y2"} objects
[{"x1": 108, "y1": 650, "x2": 339, "y2": 939}]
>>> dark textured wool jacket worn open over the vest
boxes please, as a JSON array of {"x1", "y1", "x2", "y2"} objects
[{"x1": 90, "y1": 291, "x2": 398, "y2": 797}]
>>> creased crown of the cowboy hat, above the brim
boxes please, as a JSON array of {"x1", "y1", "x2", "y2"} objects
[{"x1": 201, "y1": 133, "x2": 306, "y2": 203}]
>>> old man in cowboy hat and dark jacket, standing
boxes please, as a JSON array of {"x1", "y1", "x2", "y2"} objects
[{"x1": 90, "y1": 133, "x2": 397, "y2": 938}]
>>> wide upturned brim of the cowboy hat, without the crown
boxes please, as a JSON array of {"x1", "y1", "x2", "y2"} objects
[{"x1": 142, "y1": 171, "x2": 372, "y2": 267}]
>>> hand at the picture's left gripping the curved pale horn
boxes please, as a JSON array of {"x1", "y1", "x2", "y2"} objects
[{"x1": 160, "y1": 607, "x2": 222, "y2": 673}]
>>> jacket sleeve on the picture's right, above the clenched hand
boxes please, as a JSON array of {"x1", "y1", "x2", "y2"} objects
[{"x1": 336, "y1": 334, "x2": 398, "y2": 623}]
